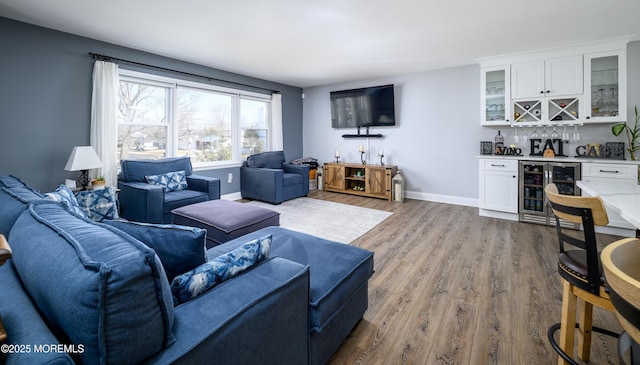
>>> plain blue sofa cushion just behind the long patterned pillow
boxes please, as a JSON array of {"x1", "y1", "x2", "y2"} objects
[{"x1": 102, "y1": 220, "x2": 207, "y2": 283}]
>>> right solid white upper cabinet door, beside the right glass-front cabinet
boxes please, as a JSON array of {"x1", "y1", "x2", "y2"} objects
[{"x1": 544, "y1": 55, "x2": 584, "y2": 97}]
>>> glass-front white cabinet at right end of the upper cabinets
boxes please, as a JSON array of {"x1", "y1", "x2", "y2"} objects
[{"x1": 584, "y1": 51, "x2": 627, "y2": 123}]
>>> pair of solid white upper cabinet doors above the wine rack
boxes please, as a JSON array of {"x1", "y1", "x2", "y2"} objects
[{"x1": 511, "y1": 55, "x2": 583, "y2": 99}]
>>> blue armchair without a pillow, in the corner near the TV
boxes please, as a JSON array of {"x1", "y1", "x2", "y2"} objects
[{"x1": 240, "y1": 151, "x2": 309, "y2": 204}]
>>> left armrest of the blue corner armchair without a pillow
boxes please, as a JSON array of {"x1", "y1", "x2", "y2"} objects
[{"x1": 240, "y1": 167, "x2": 284, "y2": 203}]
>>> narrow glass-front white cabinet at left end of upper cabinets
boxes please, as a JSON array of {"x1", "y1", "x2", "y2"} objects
[{"x1": 480, "y1": 66, "x2": 511, "y2": 126}]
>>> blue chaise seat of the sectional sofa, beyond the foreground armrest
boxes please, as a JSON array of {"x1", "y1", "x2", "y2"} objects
[{"x1": 207, "y1": 227, "x2": 373, "y2": 365}]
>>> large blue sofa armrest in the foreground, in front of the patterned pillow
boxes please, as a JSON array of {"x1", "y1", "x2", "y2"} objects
[{"x1": 147, "y1": 257, "x2": 309, "y2": 364}]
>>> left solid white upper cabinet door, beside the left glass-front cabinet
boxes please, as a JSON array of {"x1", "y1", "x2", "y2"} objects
[{"x1": 511, "y1": 61, "x2": 544, "y2": 99}]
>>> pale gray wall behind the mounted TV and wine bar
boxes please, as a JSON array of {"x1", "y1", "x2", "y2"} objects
[{"x1": 303, "y1": 42, "x2": 640, "y2": 205}]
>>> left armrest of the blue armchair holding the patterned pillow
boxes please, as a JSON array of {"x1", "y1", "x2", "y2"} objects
[{"x1": 118, "y1": 181, "x2": 164, "y2": 223}]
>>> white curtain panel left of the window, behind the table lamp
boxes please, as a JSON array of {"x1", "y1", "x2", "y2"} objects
[{"x1": 90, "y1": 61, "x2": 120, "y2": 186}]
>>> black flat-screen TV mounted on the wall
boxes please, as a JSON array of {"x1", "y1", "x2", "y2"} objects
[{"x1": 330, "y1": 85, "x2": 396, "y2": 128}]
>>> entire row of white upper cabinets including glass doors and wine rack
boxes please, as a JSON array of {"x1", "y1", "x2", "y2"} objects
[{"x1": 478, "y1": 38, "x2": 630, "y2": 126}]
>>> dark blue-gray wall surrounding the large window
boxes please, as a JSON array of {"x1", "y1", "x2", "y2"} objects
[{"x1": 0, "y1": 17, "x2": 303, "y2": 194}]
